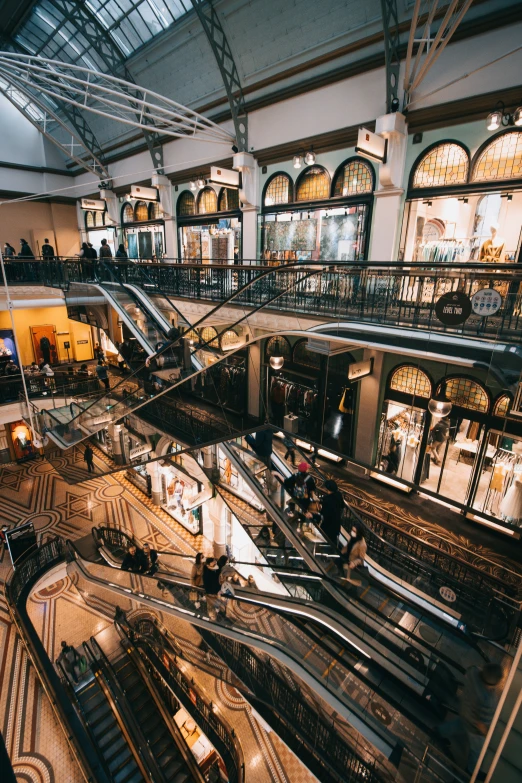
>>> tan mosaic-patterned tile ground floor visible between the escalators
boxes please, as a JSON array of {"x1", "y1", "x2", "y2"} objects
[{"x1": 0, "y1": 452, "x2": 315, "y2": 783}]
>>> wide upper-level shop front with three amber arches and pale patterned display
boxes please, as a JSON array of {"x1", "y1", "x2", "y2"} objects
[{"x1": 259, "y1": 158, "x2": 375, "y2": 264}]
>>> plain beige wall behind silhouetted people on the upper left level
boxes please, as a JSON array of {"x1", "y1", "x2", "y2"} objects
[{"x1": 0, "y1": 201, "x2": 81, "y2": 256}]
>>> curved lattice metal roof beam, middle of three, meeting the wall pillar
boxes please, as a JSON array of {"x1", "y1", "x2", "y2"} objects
[{"x1": 191, "y1": 0, "x2": 248, "y2": 152}]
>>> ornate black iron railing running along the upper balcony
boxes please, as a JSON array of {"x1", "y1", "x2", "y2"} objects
[{"x1": 5, "y1": 259, "x2": 522, "y2": 340}]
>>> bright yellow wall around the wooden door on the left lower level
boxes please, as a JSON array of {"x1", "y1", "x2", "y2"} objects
[{"x1": 0, "y1": 306, "x2": 93, "y2": 364}]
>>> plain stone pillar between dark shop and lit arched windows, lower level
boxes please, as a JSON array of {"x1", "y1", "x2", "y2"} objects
[{"x1": 354, "y1": 348, "x2": 384, "y2": 472}]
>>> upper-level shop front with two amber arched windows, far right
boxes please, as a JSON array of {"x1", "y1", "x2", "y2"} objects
[{"x1": 400, "y1": 130, "x2": 522, "y2": 272}]
